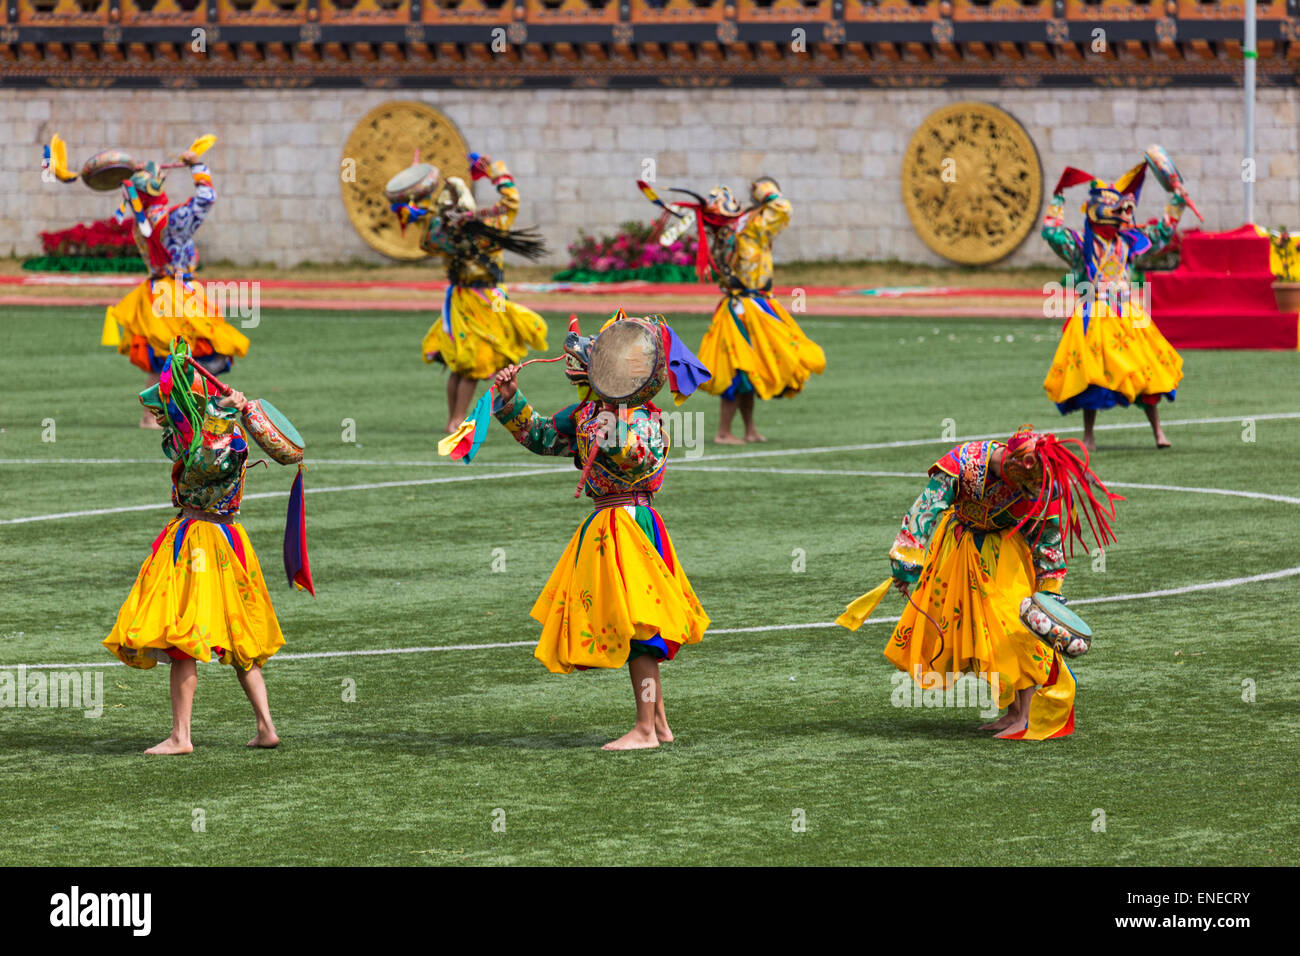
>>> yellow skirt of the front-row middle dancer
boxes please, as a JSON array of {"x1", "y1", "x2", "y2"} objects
[{"x1": 532, "y1": 506, "x2": 709, "y2": 674}]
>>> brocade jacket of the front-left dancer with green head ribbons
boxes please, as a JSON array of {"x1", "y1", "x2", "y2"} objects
[{"x1": 163, "y1": 398, "x2": 248, "y2": 516}]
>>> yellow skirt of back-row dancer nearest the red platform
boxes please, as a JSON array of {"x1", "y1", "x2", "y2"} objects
[{"x1": 1043, "y1": 299, "x2": 1183, "y2": 412}]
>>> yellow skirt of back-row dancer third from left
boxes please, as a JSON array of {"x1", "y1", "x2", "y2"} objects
[{"x1": 697, "y1": 293, "x2": 826, "y2": 399}]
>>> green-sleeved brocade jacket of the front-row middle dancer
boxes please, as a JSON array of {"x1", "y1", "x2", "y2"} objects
[{"x1": 493, "y1": 390, "x2": 670, "y2": 498}]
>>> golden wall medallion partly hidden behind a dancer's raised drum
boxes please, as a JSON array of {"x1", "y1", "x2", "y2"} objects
[{"x1": 339, "y1": 100, "x2": 469, "y2": 259}]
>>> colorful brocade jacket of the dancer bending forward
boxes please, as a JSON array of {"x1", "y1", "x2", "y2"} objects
[{"x1": 889, "y1": 441, "x2": 1066, "y2": 594}]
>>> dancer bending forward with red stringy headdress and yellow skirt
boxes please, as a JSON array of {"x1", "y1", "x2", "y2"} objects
[{"x1": 839, "y1": 427, "x2": 1122, "y2": 740}]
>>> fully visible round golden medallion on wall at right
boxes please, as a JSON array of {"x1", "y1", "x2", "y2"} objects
[{"x1": 902, "y1": 103, "x2": 1043, "y2": 265}]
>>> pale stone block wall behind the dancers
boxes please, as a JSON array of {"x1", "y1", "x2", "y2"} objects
[{"x1": 0, "y1": 88, "x2": 1300, "y2": 265}]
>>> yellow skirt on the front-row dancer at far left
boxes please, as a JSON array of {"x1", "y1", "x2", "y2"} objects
[{"x1": 104, "y1": 518, "x2": 285, "y2": 670}]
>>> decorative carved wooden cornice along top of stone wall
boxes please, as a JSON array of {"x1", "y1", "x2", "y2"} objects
[{"x1": 0, "y1": 0, "x2": 1300, "y2": 88}]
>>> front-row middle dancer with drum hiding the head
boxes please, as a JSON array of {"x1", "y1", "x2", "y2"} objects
[{"x1": 491, "y1": 311, "x2": 709, "y2": 750}]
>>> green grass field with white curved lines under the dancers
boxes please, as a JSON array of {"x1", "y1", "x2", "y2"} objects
[{"x1": 0, "y1": 308, "x2": 1300, "y2": 865}]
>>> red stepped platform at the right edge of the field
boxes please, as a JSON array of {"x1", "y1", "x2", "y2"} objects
[{"x1": 1147, "y1": 226, "x2": 1300, "y2": 350}]
